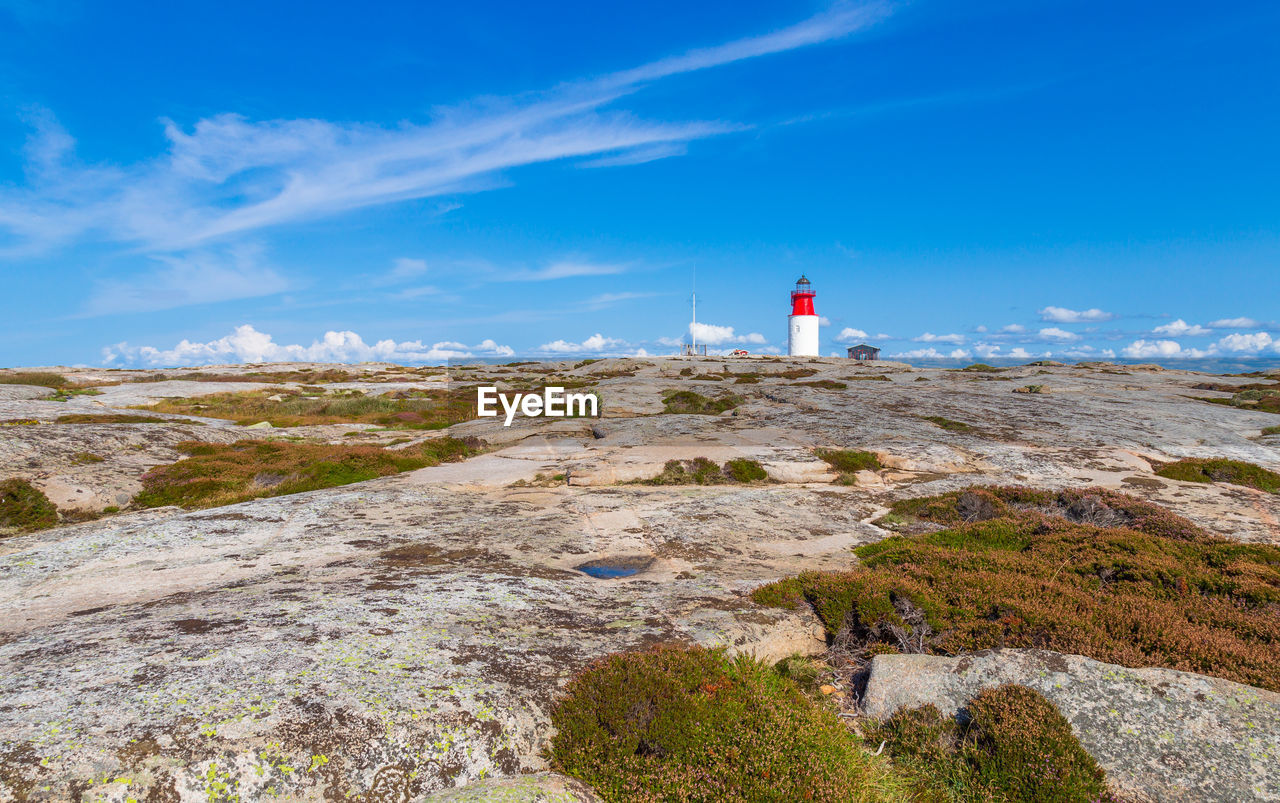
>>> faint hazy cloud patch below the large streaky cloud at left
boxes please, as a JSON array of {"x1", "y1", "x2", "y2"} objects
[{"x1": 84, "y1": 247, "x2": 291, "y2": 315}]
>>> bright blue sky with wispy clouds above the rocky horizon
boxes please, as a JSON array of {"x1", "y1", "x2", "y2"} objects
[{"x1": 0, "y1": 0, "x2": 1280, "y2": 366}]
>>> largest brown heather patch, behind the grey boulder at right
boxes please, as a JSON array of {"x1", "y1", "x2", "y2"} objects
[{"x1": 754, "y1": 488, "x2": 1280, "y2": 690}]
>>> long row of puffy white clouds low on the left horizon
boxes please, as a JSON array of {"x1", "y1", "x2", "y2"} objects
[{"x1": 102, "y1": 324, "x2": 516, "y2": 366}]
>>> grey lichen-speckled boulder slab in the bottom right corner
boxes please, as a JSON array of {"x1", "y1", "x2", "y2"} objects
[{"x1": 863, "y1": 649, "x2": 1280, "y2": 803}]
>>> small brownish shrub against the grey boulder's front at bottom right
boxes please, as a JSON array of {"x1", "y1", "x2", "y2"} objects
[{"x1": 869, "y1": 685, "x2": 1112, "y2": 803}]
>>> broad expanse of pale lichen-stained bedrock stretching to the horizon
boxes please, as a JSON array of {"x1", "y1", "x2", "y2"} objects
[{"x1": 0, "y1": 357, "x2": 1280, "y2": 803}]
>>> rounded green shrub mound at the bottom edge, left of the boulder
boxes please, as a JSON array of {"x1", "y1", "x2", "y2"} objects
[{"x1": 549, "y1": 647, "x2": 905, "y2": 803}]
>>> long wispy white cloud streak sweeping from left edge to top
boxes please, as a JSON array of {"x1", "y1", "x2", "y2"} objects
[{"x1": 0, "y1": 3, "x2": 890, "y2": 252}]
